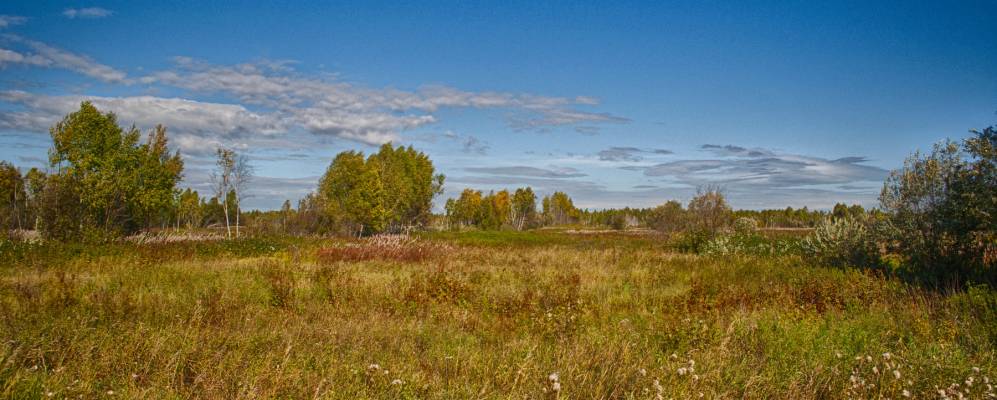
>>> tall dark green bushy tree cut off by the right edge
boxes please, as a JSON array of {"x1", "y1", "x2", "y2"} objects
[{"x1": 880, "y1": 127, "x2": 997, "y2": 283}]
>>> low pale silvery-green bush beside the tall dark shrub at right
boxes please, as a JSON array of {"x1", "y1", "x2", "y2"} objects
[{"x1": 801, "y1": 218, "x2": 879, "y2": 267}]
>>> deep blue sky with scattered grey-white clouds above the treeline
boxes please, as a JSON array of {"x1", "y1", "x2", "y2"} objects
[{"x1": 0, "y1": 1, "x2": 997, "y2": 208}]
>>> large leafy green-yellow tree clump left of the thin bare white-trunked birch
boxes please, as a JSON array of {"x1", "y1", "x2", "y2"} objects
[{"x1": 39, "y1": 102, "x2": 183, "y2": 239}]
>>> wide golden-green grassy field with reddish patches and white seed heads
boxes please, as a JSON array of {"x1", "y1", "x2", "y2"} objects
[{"x1": 0, "y1": 232, "x2": 997, "y2": 399}]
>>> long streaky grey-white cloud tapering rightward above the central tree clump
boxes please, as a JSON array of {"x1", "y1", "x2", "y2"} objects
[{"x1": 140, "y1": 57, "x2": 628, "y2": 144}]
